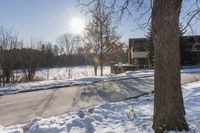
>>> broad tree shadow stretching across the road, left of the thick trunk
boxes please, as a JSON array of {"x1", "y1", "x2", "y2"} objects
[{"x1": 71, "y1": 78, "x2": 153, "y2": 106}]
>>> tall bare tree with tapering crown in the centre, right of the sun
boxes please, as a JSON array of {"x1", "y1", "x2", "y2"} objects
[{"x1": 85, "y1": 0, "x2": 120, "y2": 75}]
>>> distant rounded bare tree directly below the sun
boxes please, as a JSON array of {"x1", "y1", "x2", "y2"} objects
[{"x1": 57, "y1": 34, "x2": 80, "y2": 78}]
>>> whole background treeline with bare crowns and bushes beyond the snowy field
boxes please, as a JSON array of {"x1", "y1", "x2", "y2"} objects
[{"x1": 0, "y1": 28, "x2": 127, "y2": 86}]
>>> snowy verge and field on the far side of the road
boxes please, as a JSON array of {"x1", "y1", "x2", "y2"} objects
[{"x1": 0, "y1": 66, "x2": 200, "y2": 95}]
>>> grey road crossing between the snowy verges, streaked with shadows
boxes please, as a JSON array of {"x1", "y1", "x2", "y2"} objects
[{"x1": 0, "y1": 73, "x2": 200, "y2": 126}]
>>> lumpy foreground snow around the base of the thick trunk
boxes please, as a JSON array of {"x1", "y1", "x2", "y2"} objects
[{"x1": 0, "y1": 81, "x2": 200, "y2": 133}]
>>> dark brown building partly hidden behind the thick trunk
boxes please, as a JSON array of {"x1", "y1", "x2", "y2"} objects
[{"x1": 128, "y1": 36, "x2": 200, "y2": 69}]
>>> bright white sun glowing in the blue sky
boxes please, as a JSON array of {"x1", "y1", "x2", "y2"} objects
[{"x1": 70, "y1": 17, "x2": 85, "y2": 34}]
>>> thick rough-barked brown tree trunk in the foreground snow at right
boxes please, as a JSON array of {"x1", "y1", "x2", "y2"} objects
[{"x1": 152, "y1": 0, "x2": 188, "y2": 133}]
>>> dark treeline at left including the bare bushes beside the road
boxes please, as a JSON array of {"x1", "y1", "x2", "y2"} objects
[{"x1": 0, "y1": 45, "x2": 92, "y2": 85}]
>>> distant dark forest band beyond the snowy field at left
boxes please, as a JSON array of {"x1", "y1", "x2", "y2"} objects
[{"x1": 7, "y1": 48, "x2": 88, "y2": 70}]
